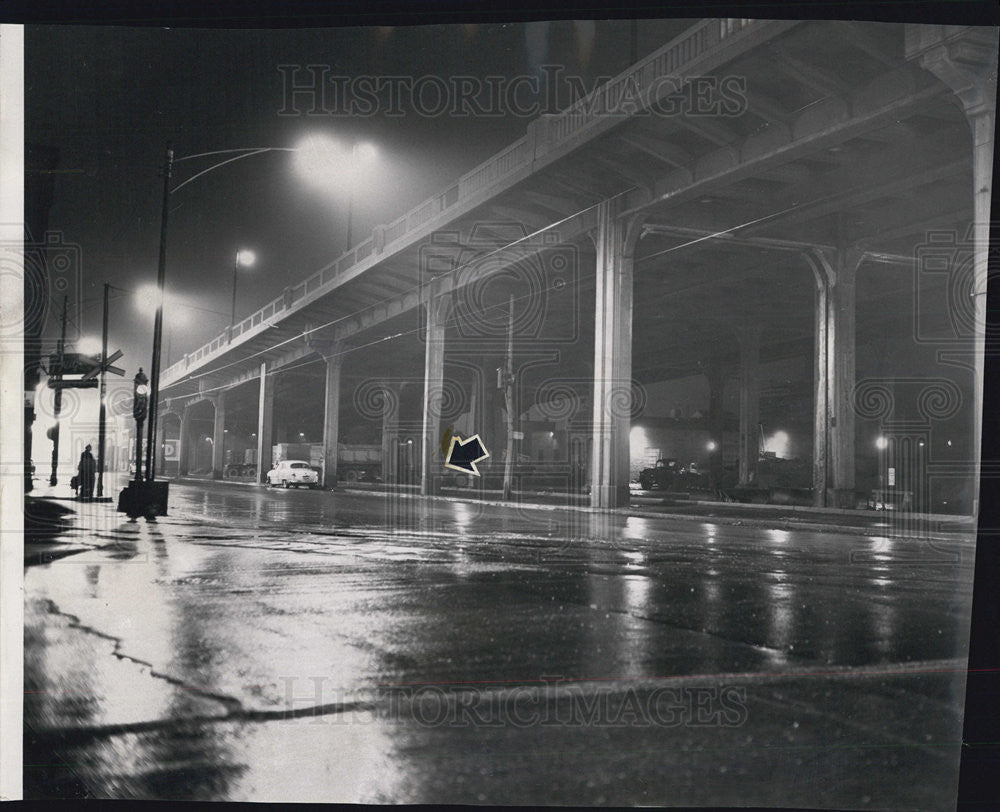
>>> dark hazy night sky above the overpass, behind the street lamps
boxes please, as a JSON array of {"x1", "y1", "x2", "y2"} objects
[{"x1": 25, "y1": 20, "x2": 693, "y2": 377}]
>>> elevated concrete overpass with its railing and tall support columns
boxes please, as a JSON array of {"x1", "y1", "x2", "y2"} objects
[{"x1": 161, "y1": 19, "x2": 997, "y2": 507}]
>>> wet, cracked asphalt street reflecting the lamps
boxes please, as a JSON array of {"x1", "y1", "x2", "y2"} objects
[{"x1": 25, "y1": 483, "x2": 974, "y2": 809}]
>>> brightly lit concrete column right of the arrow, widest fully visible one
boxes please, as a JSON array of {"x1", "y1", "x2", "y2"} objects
[{"x1": 590, "y1": 199, "x2": 638, "y2": 508}]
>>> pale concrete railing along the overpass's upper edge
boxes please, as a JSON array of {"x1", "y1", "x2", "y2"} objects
[{"x1": 162, "y1": 18, "x2": 767, "y2": 387}]
